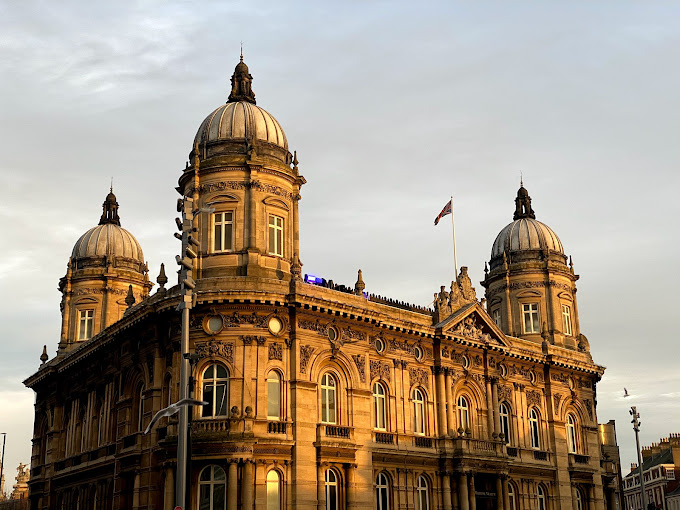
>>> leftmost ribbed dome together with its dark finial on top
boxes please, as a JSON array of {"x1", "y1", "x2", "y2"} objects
[{"x1": 71, "y1": 189, "x2": 144, "y2": 265}]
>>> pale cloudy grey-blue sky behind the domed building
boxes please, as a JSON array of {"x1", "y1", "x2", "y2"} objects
[{"x1": 0, "y1": 0, "x2": 680, "y2": 486}]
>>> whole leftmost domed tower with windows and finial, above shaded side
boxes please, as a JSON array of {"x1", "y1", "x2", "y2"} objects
[{"x1": 59, "y1": 189, "x2": 153, "y2": 351}]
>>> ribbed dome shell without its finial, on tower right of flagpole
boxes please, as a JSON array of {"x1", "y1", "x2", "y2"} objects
[{"x1": 491, "y1": 218, "x2": 564, "y2": 259}]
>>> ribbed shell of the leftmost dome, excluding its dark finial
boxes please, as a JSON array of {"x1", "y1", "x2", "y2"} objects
[{"x1": 71, "y1": 223, "x2": 144, "y2": 264}]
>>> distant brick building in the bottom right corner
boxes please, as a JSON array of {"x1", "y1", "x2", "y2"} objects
[{"x1": 623, "y1": 434, "x2": 680, "y2": 510}]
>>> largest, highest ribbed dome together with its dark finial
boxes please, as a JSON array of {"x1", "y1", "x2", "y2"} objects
[{"x1": 194, "y1": 55, "x2": 288, "y2": 150}]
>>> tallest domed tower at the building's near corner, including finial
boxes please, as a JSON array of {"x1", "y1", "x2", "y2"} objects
[{"x1": 177, "y1": 55, "x2": 305, "y2": 280}]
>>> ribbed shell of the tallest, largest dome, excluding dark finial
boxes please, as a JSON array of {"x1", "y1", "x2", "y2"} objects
[{"x1": 194, "y1": 100, "x2": 288, "y2": 150}]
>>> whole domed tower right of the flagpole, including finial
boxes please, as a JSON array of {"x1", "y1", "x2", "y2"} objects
[{"x1": 482, "y1": 185, "x2": 586, "y2": 349}]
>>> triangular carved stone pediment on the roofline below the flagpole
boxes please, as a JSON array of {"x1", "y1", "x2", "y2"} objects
[{"x1": 435, "y1": 302, "x2": 507, "y2": 346}]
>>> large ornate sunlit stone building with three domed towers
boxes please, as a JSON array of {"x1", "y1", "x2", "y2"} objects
[{"x1": 25, "y1": 56, "x2": 616, "y2": 510}]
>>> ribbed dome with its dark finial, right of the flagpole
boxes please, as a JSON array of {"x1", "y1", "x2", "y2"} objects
[{"x1": 491, "y1": 186, "x2": 564, "y2": 259}]
